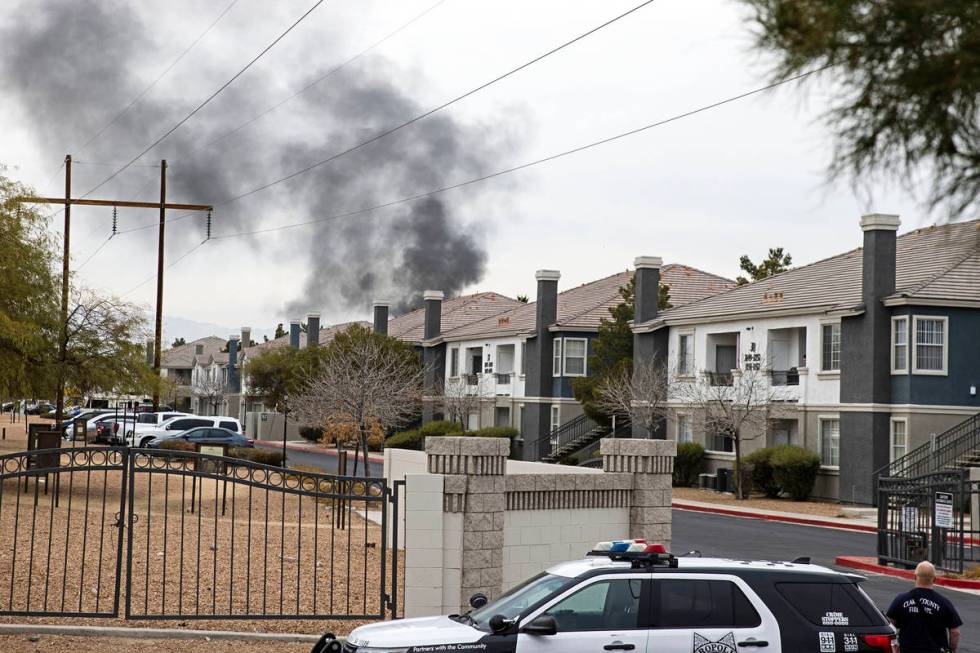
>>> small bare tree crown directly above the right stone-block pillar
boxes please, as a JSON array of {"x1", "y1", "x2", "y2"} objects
[{"x1": 595, "y1": 360, "x2": 669, "y2": 438}]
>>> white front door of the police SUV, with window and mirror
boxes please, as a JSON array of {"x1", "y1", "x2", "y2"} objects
[{"x1": 517, "y1": 573, "x2": 651, "y2": 653}]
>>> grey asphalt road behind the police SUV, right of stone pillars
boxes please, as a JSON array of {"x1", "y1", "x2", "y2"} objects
[{"x1": 671, "y1": 510, "x2": 980, "y2": 653}]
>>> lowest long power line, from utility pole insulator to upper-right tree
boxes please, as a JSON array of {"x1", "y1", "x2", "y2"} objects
[{"x1": 211, "y1": 64, "x2": 835, "y2": 240}]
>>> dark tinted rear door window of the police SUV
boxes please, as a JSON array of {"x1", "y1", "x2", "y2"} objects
[{"x1": 651, "y1": 578, "x2": 762, "y2": 628}]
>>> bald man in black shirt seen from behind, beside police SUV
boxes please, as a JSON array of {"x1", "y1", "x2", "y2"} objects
[{"x1": 887, "y1": 562, "x2": 963, "y2": 653}]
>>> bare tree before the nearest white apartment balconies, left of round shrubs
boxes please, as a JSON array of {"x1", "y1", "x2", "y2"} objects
[{"x1": 672, "y1": 368, "x2": 774, "y2": 499}]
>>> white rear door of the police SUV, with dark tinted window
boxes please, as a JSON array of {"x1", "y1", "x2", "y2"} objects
[{"x1": 649, "y1": 573, "x2": 781, "y2": 653}]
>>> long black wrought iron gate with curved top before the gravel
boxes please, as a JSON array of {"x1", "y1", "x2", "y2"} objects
[{"x1": 0, "y1": 447, "x2": 399, "y2": 619}]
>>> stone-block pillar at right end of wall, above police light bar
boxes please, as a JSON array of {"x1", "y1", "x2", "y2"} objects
[{"x1": 599, "y1": 438, "x2": 677, "y2": 550}]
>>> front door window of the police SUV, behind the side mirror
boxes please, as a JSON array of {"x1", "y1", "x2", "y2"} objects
[{"x1": 544, "y1": 578, "x2": 643, "y2": 633}]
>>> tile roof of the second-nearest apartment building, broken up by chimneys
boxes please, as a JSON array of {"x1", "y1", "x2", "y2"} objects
[{"x1": 443, "y1": 263, "x2": 735, "y2": 340}]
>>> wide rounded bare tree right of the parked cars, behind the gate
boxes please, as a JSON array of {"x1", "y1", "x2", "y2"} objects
[{"x1": 290, "y1": 325, "x2": 424, "y2": 474}]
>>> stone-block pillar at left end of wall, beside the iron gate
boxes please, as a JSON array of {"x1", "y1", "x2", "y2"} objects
[{"x1": 425, "y1": 437, "x2": 510, "y2": 609}]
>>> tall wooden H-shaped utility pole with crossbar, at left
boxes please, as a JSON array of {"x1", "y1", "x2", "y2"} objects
[{"x1": 15, "y1": 154, "x2": 214, "y2": 422}]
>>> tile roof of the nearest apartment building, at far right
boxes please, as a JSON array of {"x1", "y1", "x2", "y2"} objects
[{"x1": 646, "y1": 220, "x2": 980, "y2": 327}]
